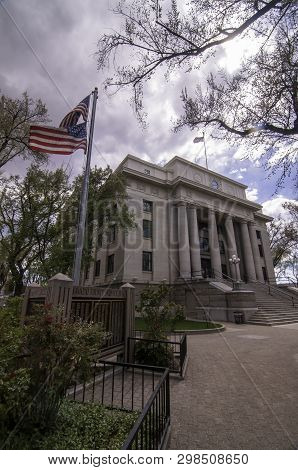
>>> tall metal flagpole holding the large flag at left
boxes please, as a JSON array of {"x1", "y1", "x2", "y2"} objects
[{"x1": 72, "y1": 88, "x2": 98, "y2": 286}]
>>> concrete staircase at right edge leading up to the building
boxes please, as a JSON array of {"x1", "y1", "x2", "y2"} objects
[{"x1": 247, "y1": 283, "x2": 298, "y2": 326}]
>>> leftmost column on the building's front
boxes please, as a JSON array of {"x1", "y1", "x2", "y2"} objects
[{"x1": 178, "y1": 202, "x2": 191, "y2": 279}]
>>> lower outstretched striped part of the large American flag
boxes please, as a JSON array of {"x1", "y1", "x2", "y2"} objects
[{"x1": 29, "y1": 122, "x2": 87, "y2": 155}]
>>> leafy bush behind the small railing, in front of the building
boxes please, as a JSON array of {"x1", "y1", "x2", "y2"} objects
[{"x1": 137, "y1": 284, "x2": 184, "y2": 340}]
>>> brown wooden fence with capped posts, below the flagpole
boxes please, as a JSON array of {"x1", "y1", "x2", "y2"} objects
[{"x1": 22, "y1": 274, "x2": 135, "y2": 361}]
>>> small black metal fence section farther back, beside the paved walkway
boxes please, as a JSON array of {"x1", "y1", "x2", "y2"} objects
[{"x1": 127, "y1": 333, "x2": 187, "y2": 377}]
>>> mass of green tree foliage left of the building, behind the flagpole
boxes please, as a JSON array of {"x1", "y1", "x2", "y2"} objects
[{"x1": 0, "y1": 165, "x2": 134, "y2": 295}]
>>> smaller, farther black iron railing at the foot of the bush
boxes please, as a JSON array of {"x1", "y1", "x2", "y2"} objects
[{"x1": 127, "y1": 333, "x2": 187, "y2": 377}]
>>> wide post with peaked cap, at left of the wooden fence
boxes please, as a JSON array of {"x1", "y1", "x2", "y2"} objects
[{"x1": 45, "y1": 273, "x2": 73, "y2": 321}]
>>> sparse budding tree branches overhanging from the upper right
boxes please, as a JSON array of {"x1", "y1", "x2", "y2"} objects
[{"x1": 97, "y1": 0, "x2": 298, "y2": 183}]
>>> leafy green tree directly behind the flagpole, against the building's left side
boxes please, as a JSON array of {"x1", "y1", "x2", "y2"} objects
[{"x1": 39, "y1": 167, "x2": 134, "y2": 279}]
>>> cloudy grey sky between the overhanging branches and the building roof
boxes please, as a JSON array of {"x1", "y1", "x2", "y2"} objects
[{"x1": 0, "y1": 0, "x2": 294, "y2": 215}]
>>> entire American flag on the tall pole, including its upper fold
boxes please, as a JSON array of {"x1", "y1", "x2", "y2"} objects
[{"x1": 29, "y1": 95, "x2": 90, "y2": 155}]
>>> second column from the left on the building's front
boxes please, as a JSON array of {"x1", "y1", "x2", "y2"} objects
[{"x1": 188, "y1": 206, "x2": 202, "y2": 279}]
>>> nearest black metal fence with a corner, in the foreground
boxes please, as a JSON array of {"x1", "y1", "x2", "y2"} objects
[{"x1": 67, "y1": 360, "x2": 170, "y2": 450}]
